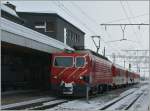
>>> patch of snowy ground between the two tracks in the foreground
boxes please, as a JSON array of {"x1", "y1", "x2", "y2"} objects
[{"x1": 50, "y1": 94, "x2": 117, "y2": 111}]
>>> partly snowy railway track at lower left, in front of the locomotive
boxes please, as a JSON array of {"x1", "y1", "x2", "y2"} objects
[{"x1": 1, "y1": 97, "x2": 69, "y2": 110}]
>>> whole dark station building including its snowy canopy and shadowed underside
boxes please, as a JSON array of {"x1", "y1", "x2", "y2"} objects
[{"x1": 0, "y1": 3, "x2": 84, "y2": 92}]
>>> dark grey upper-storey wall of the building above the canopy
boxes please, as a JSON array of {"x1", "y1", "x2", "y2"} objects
[{"x1": 18, "y1": 12, "x2": 84, "y2": 47}]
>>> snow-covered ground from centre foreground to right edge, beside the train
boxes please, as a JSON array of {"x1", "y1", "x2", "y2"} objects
[{"x1": 49, "y1": 84, "x2": 149, "y2": 111}]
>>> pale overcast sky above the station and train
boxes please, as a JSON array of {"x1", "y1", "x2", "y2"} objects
[{"x1": 1, "y1": 0, "x2": 149, "y2": 76}]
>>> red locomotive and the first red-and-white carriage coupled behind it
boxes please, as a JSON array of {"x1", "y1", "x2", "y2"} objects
[{"x1": 51, "y1": 50, "x2": 140, "y2": 96}]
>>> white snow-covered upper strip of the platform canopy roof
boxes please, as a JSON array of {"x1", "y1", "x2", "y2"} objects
[{"x1": 0, "y1": 17, "x2": 74, "y2": 50}]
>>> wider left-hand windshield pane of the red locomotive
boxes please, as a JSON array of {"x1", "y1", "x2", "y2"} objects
[{"x1": 54, "y1": 57, "x2": 73, "y2": 67}]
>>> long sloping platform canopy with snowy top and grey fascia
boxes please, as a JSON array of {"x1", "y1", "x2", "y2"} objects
[{"x1": 0, "y1": 17, "x2": 74, "y2": 53}]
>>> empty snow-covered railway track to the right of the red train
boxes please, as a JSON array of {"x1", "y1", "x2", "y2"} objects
[{"x1": 100, "y1": 87, "x2": 145, "y2": 110}]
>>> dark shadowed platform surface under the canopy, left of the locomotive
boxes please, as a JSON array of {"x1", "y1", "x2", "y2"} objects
[{"x1": 1, "y1": 90, "x2": 52, "y2": 105}]
